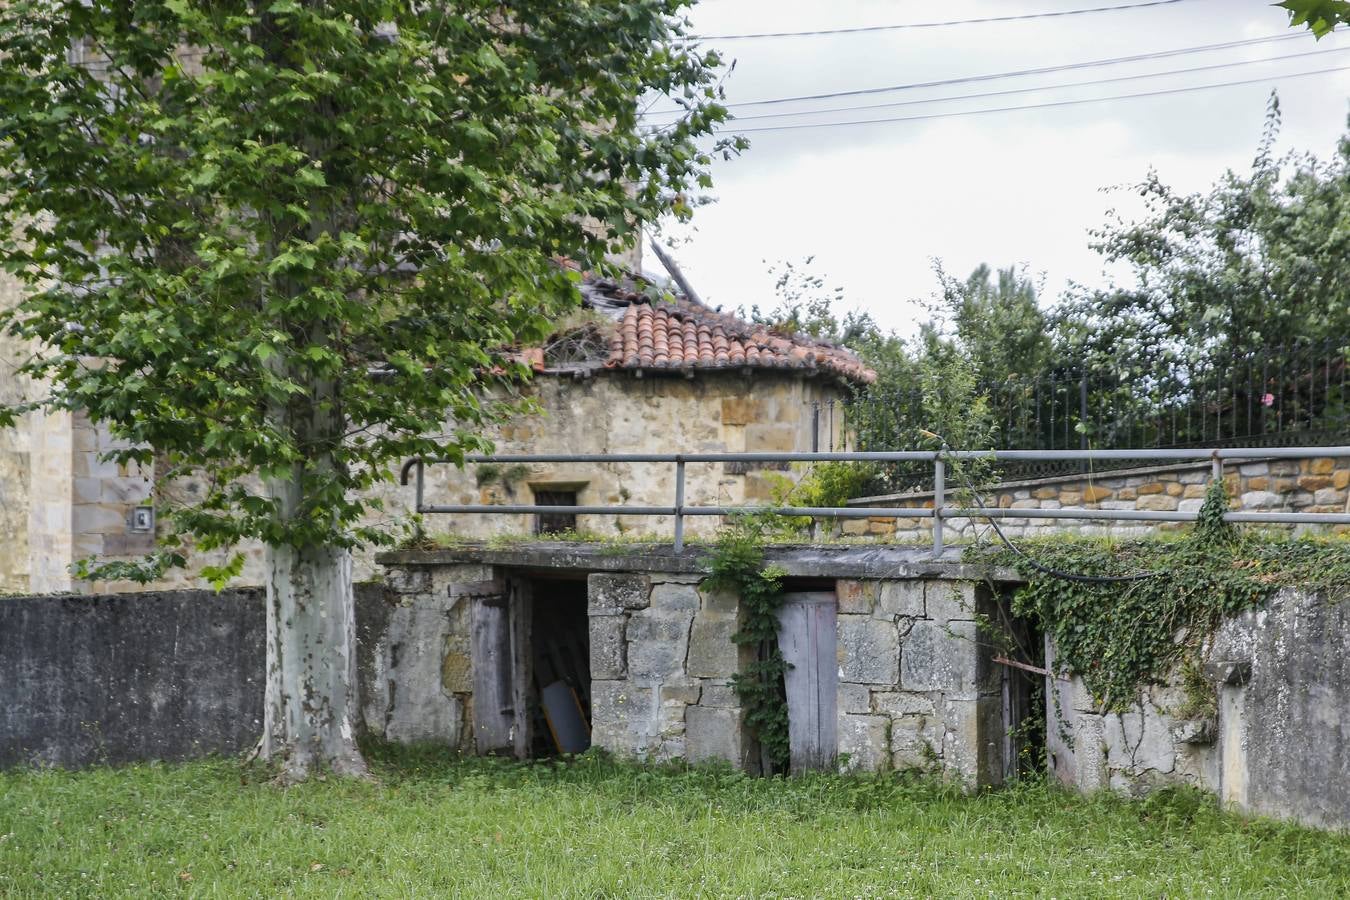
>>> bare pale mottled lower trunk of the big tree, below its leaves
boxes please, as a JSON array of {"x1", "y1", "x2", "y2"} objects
[{"x1": 259, "y1": 534, "x2": 366, "y2": 783}]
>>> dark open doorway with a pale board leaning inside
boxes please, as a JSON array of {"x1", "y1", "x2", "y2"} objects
[{"x1": 529, "y1": 579, "x2": 591, "y2": 757}]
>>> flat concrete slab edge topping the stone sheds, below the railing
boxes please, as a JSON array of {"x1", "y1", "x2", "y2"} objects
[{"x1": 375, "y1": 541, "x2": 1022, "y2": 583}]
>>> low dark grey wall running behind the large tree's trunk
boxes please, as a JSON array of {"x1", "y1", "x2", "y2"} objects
[{"x1": 0, "y1": 584, "x2": 442, "y2": 766}]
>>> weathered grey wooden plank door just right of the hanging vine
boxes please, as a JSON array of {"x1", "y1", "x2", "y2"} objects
[{"x1": 778, "y1": 592, "x2": 838, "y2": 773}]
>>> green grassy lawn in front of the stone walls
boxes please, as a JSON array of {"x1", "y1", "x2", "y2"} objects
[{"x1": 0, "y1": 749, "x2": 1350, "y2": 897}]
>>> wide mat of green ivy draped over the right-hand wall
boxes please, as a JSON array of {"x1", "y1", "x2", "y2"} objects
[{"x1": 968, "y1": 482, "x2": 1350, "y2": 711}]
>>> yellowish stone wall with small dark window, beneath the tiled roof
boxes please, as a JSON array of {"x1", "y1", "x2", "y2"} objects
[{"x1": 394, "y1": 372, "x2": 841, "y2": 541}]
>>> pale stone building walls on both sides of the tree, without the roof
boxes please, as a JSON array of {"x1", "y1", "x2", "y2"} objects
[{"x1": 0, "y1": 371, "x2": 842, "y2": 592}]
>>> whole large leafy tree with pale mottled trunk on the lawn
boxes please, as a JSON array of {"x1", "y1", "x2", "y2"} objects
[{"x1": 0, "y1": 0, "x2": 738, "y2": 780}]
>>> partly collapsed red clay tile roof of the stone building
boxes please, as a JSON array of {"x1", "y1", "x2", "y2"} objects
[{"x1": 548, "y1": 274, "x2": 876, "y2": 385}]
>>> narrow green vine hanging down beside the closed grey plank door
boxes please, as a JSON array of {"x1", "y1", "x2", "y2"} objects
[{"x1": 709, "y1": 515, "x2": 788, "y2": 772}]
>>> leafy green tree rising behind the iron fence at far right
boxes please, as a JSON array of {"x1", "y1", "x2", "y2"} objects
[{"x1": 1052, "y1": 94, "x2": 1350, "y2": 383}]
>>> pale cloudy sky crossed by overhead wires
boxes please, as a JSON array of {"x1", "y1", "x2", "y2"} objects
[{"x1": 644, "y1": 0, "x2": 1350, "y2": 335}]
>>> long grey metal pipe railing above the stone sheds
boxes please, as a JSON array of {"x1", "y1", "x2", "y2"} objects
[{"x1": 400, "y1": 447, "x2": 1350, "y2": 556}]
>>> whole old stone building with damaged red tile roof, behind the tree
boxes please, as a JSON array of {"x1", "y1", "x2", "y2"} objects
[{"x1": 0, "y1": 277, "x2": 873, "y2": 592}]
